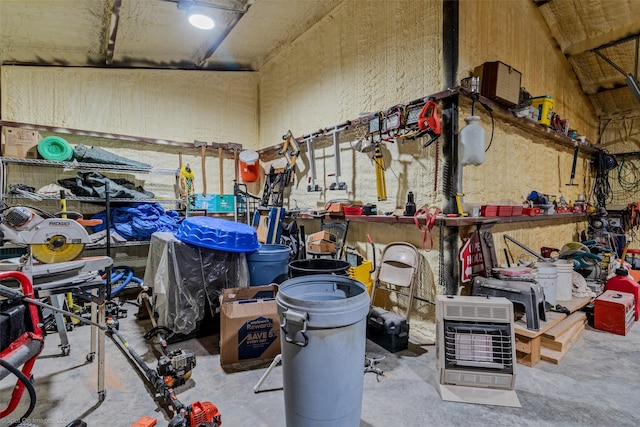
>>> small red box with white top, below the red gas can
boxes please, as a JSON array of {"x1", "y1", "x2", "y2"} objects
[{"x1": 593, "y1": 291, "x2": 635, "y2": 335}]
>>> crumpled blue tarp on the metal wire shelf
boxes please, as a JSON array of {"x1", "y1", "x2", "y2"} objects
[{"x1": 92, "y1": 203, "x2": 183, "y2": 240}]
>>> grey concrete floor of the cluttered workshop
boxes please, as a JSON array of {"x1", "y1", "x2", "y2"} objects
[{"x1": 0, "y1": 305, "x2": 640, "y2": 427}]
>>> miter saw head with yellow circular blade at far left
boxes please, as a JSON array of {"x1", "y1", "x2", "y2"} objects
[{"x1": 0, "y1": 206, "x2": 91, "y2": 264}]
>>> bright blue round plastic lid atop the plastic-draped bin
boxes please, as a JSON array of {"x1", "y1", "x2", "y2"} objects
[{"x1": 175, "y1": 216, "x2": 261, "y2": 252}]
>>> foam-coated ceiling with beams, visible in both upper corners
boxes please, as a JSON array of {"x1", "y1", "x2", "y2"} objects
[{"x1": 0, "y1": 0, "x2": 640, "y2": 117}]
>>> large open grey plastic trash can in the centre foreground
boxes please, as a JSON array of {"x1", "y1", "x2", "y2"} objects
[{"x1": 276, "y1": 274, "x2": 370, "y2": 427}]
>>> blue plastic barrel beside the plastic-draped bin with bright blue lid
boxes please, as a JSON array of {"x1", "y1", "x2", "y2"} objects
[{"x1": 247, "y1": 245, "x2": 291, "y2": 286}]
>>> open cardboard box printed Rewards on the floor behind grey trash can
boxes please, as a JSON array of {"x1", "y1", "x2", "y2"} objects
[{"x1": 220, "y1": 285, "x2": 280, "y2": 369}]
